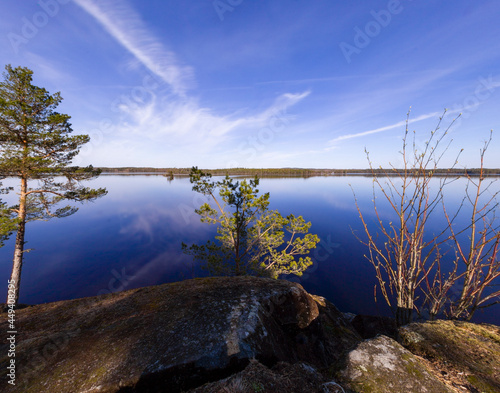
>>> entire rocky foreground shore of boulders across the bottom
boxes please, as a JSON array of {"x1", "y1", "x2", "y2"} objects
[{"x1": 0, "y1": 277, "x2": 500, "y2": 393}]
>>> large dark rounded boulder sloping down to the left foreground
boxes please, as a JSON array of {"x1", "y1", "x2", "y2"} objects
[{"x1": 0, "y1": 277, "x2": 360, "y2": 393}]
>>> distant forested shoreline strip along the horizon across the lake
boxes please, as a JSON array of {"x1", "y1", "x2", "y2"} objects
[{"x1": 99, "y1": 167, "x2": 500, "y2": 177}]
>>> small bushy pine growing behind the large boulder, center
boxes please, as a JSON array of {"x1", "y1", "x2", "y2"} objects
[{"x1": 182, "y1": 167, "x2": 319, "y2": 278}]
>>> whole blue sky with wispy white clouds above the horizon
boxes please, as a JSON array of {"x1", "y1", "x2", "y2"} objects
[{"x1": 0, "y1": 0, "x2": 500, "y2": 168}]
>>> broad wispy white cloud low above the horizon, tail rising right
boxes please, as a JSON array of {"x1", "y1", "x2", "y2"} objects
[{"x1": 80, "y1": 92, "x2": 309, "y2": 167}]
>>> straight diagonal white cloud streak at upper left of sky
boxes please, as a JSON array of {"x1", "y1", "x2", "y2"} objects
[{"x1": 75, "y1": 0, "x2": 194, "y2": 95}]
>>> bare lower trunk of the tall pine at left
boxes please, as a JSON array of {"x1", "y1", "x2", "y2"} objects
[{"x1": 7, "y1": 177, "x2": 28, "y2": 305}]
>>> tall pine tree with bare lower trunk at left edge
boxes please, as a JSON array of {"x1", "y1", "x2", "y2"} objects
[{"x1": 0, "y1": 65, "x2": 106, "y2": 304}]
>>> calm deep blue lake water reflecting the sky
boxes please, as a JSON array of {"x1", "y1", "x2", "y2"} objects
[{"x1": 0, "y1": 175, "x2": 500, "y2": 324}]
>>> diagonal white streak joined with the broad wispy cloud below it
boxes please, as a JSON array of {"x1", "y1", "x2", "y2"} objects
[{"x1": 71, "y1": 0, "x2": 310, "y2": 167}]
